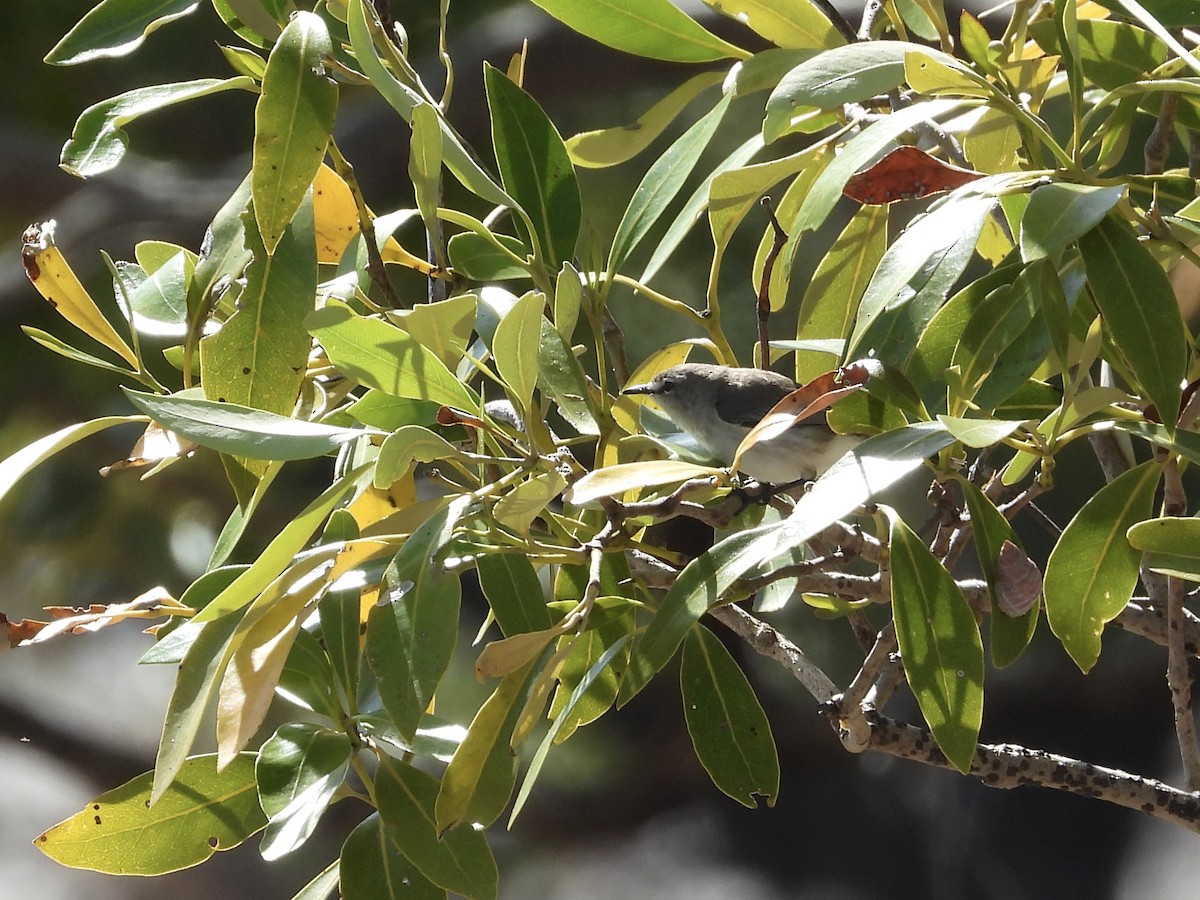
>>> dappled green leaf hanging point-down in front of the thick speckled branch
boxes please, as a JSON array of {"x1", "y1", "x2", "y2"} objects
[{"x1": 886, "y1": 510, "x2": 983, "y2": 774}]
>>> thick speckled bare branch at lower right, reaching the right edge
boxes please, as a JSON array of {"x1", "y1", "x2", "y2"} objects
[{"x1": 866, "y1": 710, "x2": 1200, "y2": 834}]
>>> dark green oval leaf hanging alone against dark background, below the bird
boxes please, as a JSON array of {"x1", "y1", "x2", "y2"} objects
[{"x1": 679, "y1": 624, "x2": 779, "y2": 809}]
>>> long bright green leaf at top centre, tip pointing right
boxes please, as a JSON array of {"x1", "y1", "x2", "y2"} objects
[{"x1": 534, "y1": 0, "x2": 750, "y2": 62}]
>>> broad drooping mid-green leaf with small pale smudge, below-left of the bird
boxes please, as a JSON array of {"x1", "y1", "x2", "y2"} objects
[{"x1": 366, "y1": 496, "x2": 470, "y2": 739}]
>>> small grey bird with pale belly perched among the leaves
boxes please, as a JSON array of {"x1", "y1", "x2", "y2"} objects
[{"x1": 622, "y1": 362, "x2": 862, "y2": 485}]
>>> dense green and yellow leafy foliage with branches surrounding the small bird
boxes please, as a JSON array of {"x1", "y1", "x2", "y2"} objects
[{"x1": 7, "y1": 0, "x2": 1200, "y2": 898}]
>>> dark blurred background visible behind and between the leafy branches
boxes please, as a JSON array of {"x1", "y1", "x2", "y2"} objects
[{"x1": 0, "y1": 0, "x2": 1200, "y2": 900}]
